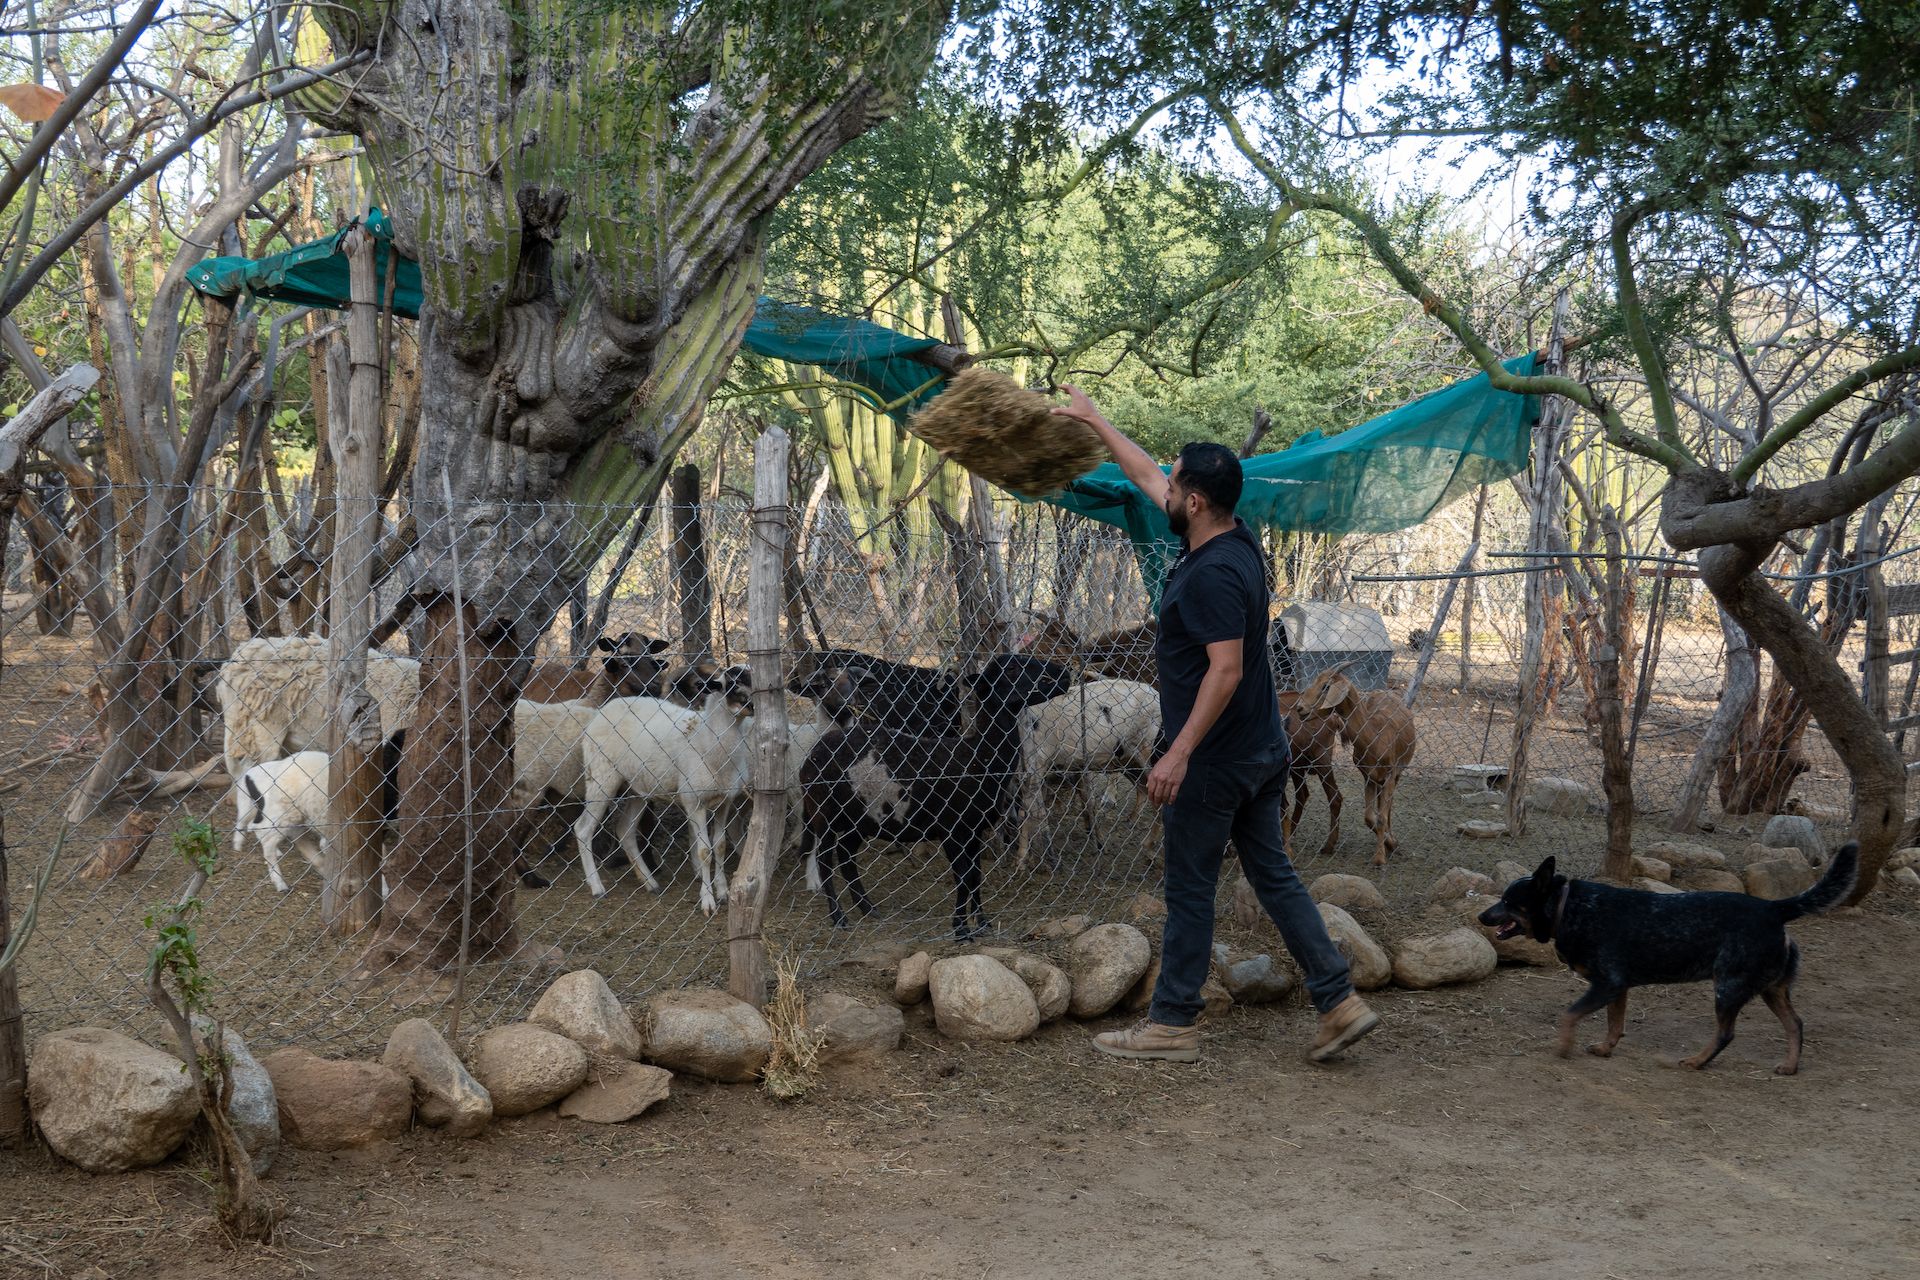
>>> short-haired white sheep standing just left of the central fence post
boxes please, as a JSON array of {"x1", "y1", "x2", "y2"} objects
[{"x1": 574, "y1": 668, "x2": 751, "y2": 915}]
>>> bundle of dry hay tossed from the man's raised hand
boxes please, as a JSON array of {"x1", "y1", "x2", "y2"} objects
[{"x1": 908, "y1": 365, "x2": 1108, "y2": 497}]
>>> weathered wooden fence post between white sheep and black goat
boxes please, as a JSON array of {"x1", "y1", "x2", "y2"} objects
[{"x1": 726, "y1": 426, "x2": 787, "y2": 1006}]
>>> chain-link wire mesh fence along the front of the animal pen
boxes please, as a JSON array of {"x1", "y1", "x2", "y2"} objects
[{"x1": 0, "y1": 475, "x2": 1889, "y2": 1048}]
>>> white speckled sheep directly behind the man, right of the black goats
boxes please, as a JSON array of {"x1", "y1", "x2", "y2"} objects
[{"x1": 1018, "y1": 679, "x2": 1160, "y2": 867}]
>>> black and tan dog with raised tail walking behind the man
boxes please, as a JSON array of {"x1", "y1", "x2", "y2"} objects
[{"x1": 1480, "y1": 844, "x2": 1860, "y2": 1075}]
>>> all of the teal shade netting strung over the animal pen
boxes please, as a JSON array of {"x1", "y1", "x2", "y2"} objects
[{"x1": 186, "y1": 209, "x2": 1540, "y2": 606}]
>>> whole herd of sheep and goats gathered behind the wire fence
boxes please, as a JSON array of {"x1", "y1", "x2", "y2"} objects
[{"x1": 215, "y1": 622, "x2": 1413, "y2": 940}]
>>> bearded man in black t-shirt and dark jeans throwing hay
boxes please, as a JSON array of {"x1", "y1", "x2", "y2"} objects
[{"x1": 1054, "y1": 386, "x2": 1380, "y2": 1063}]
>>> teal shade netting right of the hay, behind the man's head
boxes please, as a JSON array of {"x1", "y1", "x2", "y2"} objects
[{"x1": 1046, "y1": 353, "x2": 1540, "y2": 606}]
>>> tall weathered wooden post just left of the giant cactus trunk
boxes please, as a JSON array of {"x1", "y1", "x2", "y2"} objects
[{"x1": 321, "y1": 228, "x2": 382, "y2": 935}]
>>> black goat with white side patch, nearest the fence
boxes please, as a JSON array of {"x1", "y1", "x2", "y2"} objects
[{"x1": 801, "y1": 654, "x2": 1073, "y2": 942}]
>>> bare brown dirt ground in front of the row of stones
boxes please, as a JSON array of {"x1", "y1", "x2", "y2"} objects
[{"x1": 0, "y1": 912, "x2": 1920, "y2": 1280}]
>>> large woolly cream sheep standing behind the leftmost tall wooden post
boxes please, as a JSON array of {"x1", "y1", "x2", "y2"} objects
[{"x1": 215, "y1": 635, "x2": 420, "y2": 779}]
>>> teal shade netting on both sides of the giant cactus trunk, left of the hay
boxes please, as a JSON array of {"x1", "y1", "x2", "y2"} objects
[{"x1": 186, "y1": 209, "x2": 941, "y2": 418}]
